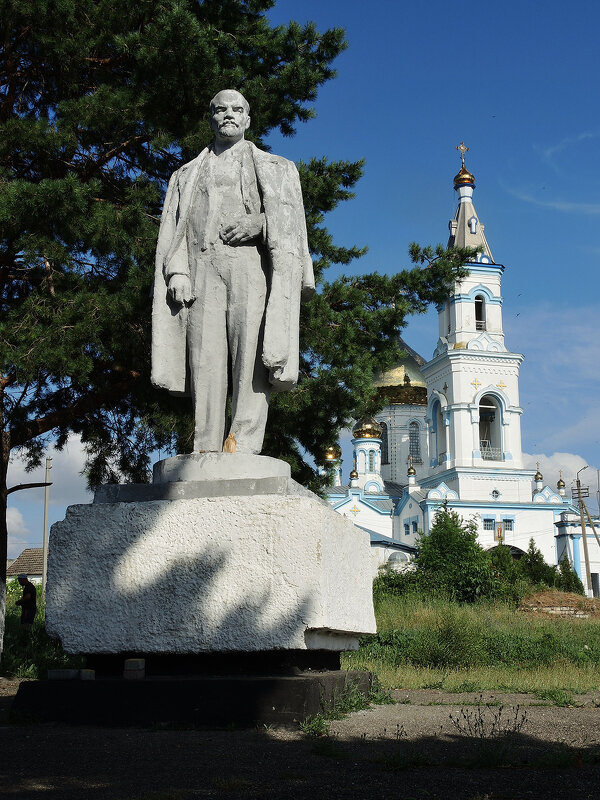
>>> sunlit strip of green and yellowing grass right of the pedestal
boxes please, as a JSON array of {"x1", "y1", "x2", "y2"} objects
[{"x1": 343, "y1": 595, "x2": 600, "y2": 704}]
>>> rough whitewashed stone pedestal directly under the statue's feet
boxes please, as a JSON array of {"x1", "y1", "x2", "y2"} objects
[{"x1": 46, "y1": 453, "x2": 375, "y2": 654}]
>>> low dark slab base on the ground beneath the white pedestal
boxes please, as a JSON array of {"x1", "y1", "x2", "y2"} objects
[{"x1": 11, "y1": 671, "x2": 372, "y2": 727}]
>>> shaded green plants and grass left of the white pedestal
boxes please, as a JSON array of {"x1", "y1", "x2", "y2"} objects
[{"x1": 2, "y1": 580, "x2": 84, "y2": 679}]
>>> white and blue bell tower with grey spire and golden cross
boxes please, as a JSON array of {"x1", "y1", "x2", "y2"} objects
[{"x1": 421, "y1": 142, "x2": 523, "y2": 488}]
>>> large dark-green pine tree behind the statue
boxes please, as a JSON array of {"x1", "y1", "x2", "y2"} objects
[{"x1": 0, "y1": 0, "x2": 467, "y2": 648}]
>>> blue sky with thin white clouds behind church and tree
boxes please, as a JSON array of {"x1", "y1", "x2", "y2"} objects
[{"x1": 9, "y1": 0, "x2": 600, "y2": 555}]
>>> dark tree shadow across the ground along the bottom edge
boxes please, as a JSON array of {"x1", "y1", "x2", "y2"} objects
[{"x1": 0, "y1": 725, "x2": 600, "y2": 800}]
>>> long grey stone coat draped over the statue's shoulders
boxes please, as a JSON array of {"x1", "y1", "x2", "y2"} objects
[{"x1": 152, "y1": 142, "x2": 314, "y2": 394}]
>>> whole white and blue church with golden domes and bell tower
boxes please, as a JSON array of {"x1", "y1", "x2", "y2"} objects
[{"x1": 326, "y1": 143, "x2": 600, "y2": 590}]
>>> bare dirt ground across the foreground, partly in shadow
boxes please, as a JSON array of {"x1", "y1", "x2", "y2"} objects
[{"x1": 0, "y1": 678, "x2": 600, "y2": 800}]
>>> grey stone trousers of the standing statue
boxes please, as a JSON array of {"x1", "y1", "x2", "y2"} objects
[{"x1": 187, "y1": 242, "x2": 270, "y2": 453}]
